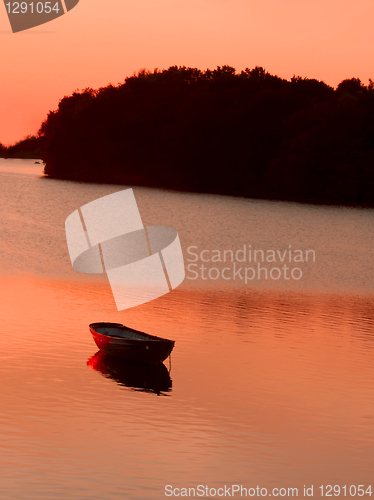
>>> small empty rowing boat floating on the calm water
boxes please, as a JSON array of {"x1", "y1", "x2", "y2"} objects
[{"x1": 89, "y1": 323, "x2": 174, "y2": 365}]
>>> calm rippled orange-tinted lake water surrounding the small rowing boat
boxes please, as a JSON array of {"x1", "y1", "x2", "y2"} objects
[{"x1": 0, "y1": 160, "x2": 374, "y2": 500}]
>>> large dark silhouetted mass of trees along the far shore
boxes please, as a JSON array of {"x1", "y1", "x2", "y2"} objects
[{"x1": 2, "y1": 66, "x2": 374, "y2": 205}]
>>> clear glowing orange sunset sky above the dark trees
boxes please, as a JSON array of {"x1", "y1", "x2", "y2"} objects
[{"x1": 0, "y1": 0, "x2": 374, "y2": 144}]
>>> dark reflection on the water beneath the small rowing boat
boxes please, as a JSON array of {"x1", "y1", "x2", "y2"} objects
[{"x1": 87, "y1": 351, "x2": 172, "y2": 395}]
